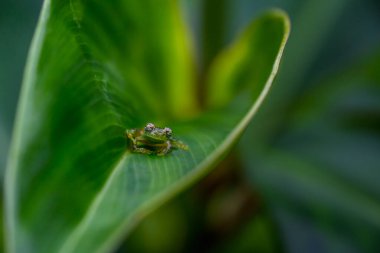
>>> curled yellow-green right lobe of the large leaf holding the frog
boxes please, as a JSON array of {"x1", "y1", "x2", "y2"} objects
[{"x1": 207, "y1": 12, "x2": 290, "y2": 107}]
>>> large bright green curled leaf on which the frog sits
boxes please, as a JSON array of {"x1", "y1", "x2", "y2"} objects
[{"x1": 6, "y1": 0, "x2": 289, "y2": 252}]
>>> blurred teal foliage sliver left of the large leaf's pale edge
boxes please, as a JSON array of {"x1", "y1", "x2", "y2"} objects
[{"x1": 0, "y1": 0, "x2": 40, "y2": 181}]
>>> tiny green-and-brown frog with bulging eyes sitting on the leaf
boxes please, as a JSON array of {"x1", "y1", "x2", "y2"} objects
[{"x1": 125, "y1": 123, "x2": 189, "y2": 156}]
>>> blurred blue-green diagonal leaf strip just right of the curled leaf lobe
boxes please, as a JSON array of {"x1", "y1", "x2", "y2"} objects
[{"x1": 246, "y1": 0, "x2": 350, "y2": 148}]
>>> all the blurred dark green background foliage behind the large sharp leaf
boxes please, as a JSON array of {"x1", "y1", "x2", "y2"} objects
[{"x1": 0, "y1": 0, "x2": 380, "y2": 252}]
